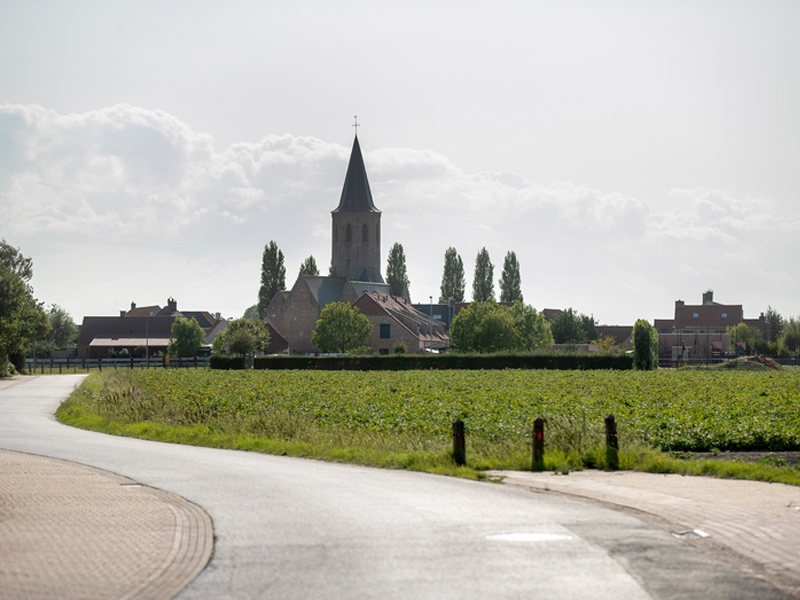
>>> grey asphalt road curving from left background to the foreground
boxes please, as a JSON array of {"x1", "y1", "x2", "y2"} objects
[{"x1": 0, "y1": 375, "x2": 786, "y2": 600}]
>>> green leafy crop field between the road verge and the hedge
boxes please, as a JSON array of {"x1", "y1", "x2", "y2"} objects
[{"x1": 90, "y1": 369, "x2": 800, "y2": 451}]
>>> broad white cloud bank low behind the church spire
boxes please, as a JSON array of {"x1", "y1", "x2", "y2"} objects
[{"x1": 0, "y1": 105, "x2": 800, "y2": 322}]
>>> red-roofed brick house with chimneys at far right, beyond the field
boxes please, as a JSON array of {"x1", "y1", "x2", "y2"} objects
[{"x1": 653, "y1": 290, "x2": 770, "y2": 358}]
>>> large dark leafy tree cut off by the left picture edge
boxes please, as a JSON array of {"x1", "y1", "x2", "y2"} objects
[{"x1": 0, "y1": 240, "x2": 50, "y2": 376}]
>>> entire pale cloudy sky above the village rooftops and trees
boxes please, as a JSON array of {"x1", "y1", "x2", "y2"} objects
[{"x1": 0, "y1": 0, "x2": 800, "y2": 325}]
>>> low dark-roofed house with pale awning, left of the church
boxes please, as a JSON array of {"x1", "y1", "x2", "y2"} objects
[{"x1": 78, "y1": 298, "x2": 228, "y2": 358}]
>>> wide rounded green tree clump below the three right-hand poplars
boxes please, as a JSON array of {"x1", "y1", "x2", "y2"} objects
[{"x1": 450, "y1": 298, "x2": 553, "y2": 352}]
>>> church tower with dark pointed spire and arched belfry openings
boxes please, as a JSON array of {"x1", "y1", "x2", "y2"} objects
[{"x1": 331, "y1": 133, "x2": 383, "y2": 283}]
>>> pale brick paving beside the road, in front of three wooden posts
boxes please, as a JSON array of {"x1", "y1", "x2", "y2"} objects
[{"x1": 488, "y1": 471, "x2": 800, "y2": 598}]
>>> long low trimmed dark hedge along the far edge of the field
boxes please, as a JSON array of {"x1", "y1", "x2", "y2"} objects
[{"x1": 255, "y1": 354, "x2": 633, "y2": 371}]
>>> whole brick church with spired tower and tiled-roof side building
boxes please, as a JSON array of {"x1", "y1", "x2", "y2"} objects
[{"x1": 264, "y1": 133, "x2": 450, "y2": 354}]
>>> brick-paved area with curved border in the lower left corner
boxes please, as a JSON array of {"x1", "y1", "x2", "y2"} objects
[{"x1": 0, "y1": 450, "x2": 213, "y2": 600}]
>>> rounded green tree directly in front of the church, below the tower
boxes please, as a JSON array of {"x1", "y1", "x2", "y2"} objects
[{"x1": 311, "y1": 302, "x2": 372, "y2": 354}]
